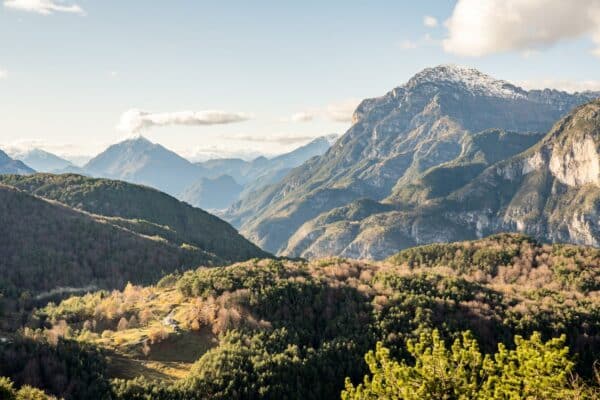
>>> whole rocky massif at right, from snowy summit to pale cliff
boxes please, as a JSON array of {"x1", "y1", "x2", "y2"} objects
[{"x1": 226, "y1": 65, "x2": 600, "y2": 259}]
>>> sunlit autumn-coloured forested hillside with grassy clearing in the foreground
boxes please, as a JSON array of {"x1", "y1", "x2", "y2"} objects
[{"x1": 0, "y1": 234, "x2": 600, "y2": 399}]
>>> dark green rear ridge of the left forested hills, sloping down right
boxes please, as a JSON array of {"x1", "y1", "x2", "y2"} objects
[{"x1": 0, "y1": 174, "x2": 266, "y2": 262}]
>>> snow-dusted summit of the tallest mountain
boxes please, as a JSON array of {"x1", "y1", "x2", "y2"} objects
[{"x1": 406, "y1": 64, "x2": 527, "y2": 98}]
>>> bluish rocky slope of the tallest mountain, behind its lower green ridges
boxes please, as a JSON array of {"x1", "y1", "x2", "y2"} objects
[{"x1": 226, "y1": 66, "x2": 596, "y2": 254}]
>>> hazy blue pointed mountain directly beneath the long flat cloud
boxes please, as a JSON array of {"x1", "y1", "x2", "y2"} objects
[{"x1": 83, "y1": 136, "x2": 204, "y2": 196}]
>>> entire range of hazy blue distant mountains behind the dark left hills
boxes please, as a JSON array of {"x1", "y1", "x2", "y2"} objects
[{"x1": 0, "y1": 135, "x2": 337, "y2": 210}]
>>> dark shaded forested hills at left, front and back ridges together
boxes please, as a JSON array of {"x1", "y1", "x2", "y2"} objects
[{"x1": 0, "y1": 174, "x2": 268, "y2": 297}]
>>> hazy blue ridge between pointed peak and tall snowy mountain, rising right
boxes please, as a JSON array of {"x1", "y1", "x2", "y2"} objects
[{"x1": 180, "y1": 135, "x2": 337, "y2": 210}]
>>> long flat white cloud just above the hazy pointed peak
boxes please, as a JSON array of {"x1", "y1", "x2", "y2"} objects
[{"x1": 117, "y1": 109, "x2": 251, "y2": 133}]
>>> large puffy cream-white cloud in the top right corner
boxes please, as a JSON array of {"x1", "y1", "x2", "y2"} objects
[{"x1": 443, "y1": 0, "x2": 600, "y2": 57}]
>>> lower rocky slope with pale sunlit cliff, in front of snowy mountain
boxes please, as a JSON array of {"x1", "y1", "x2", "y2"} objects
[{"x1": 285, "y1": 100, "x2": 600, "y2": 258}]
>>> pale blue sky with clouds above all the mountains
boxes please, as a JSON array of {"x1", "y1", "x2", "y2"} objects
[{"x1": 0, "y1": 0, "x2": 600, "y2": 159}]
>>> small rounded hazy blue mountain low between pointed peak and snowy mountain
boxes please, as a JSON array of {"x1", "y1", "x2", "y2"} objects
[{"x1": 181, "y1": 175, "x2": 243, "y2": 210}]
